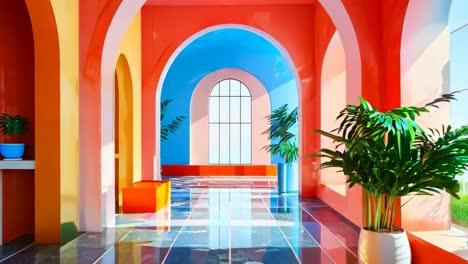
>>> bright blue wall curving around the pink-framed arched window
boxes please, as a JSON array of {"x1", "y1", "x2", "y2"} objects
[{"x1": 161, "y1": 29, "x2": 298, "y2": 164}]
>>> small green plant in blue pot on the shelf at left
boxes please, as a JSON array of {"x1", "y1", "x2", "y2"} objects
[{"x1": 0, "y1": 113, "x2": 28, "y2": 160}]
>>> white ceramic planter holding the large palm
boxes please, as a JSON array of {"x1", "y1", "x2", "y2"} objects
[{"x1": 359, "y1": 229, "x2": 411, "y2": 264}]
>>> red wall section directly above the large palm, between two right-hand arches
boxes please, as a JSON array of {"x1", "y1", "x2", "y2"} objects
[{"x1": 340, "y1": 0, "x2": 409, "y2": 225}]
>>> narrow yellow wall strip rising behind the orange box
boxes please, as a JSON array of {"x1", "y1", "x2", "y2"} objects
[{"x1": 119, "y1": 12, "x2": 141, "y2": 182}]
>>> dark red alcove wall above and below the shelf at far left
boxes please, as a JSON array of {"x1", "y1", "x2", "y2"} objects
[{"x1": 0, "y1": 1, "x2": 34, "y2": 242}]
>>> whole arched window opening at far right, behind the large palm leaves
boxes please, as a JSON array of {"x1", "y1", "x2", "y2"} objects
[{"x1": 400, "y1": 1, "x2": 468, "y2": 257}]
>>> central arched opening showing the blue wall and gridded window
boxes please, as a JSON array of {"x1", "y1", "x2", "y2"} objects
[{"x1": 156, "y1": 25, "x2": 300, "y2": 175}]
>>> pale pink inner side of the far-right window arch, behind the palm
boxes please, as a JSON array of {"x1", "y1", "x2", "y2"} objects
[{"x1": 400, "y1": 1, "x2": 451, "y2": 231}]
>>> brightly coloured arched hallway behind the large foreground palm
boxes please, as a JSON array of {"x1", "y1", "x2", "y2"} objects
[{"x1": 0, "y1": 0, "x2": 468, "y2": 264}]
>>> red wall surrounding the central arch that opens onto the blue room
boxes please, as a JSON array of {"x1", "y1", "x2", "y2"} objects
[{"x1": 142, "y1": 5, "x2": 320, "y2": 196}]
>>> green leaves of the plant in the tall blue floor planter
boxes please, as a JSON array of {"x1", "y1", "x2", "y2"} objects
[{"x1": 262, "y1": 104, "x2": 298, "y2": 163}]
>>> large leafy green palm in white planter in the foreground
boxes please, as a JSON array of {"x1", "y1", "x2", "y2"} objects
[{"x1": 310, "y1": 93, "x2": 468, "y2": 263}]
